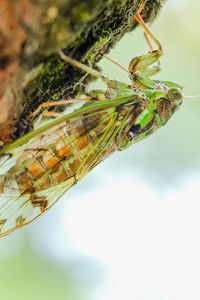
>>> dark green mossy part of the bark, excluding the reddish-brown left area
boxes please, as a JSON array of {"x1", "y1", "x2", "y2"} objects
[{"x1": 2, "y1": 0, "x2": 164, "y2": 142}]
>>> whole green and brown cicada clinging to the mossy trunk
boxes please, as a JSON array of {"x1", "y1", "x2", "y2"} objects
[{"x1": 0, "y1": 2, "x2": 182, "y2": 236}]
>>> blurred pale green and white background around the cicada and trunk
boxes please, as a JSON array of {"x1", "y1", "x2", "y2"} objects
[{"x1": 0, "y1": 0, "x2": 200, "y2": 300}]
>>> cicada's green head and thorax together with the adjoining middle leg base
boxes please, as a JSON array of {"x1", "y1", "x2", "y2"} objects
[{"x1": 107, "y1": 77, "x2": 182, "y2": 150}]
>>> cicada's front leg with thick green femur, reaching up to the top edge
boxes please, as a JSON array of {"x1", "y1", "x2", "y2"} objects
[{"x1": 128, "y1": 1, "x2": 163, "y2": 82}]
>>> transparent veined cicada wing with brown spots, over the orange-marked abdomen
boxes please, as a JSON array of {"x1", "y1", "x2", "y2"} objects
[{"x1": 0, "y1": 98, "x2": 134, "y2": 236}]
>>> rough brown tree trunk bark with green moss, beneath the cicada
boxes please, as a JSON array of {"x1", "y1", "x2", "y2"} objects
[{"x1": 0, "y1": 0, "x2": 165, "y2": 146}]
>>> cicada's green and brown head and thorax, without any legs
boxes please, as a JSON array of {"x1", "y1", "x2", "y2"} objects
[{"x1": 119, "y1": 81, "x2": 183, "y2": 149}]
